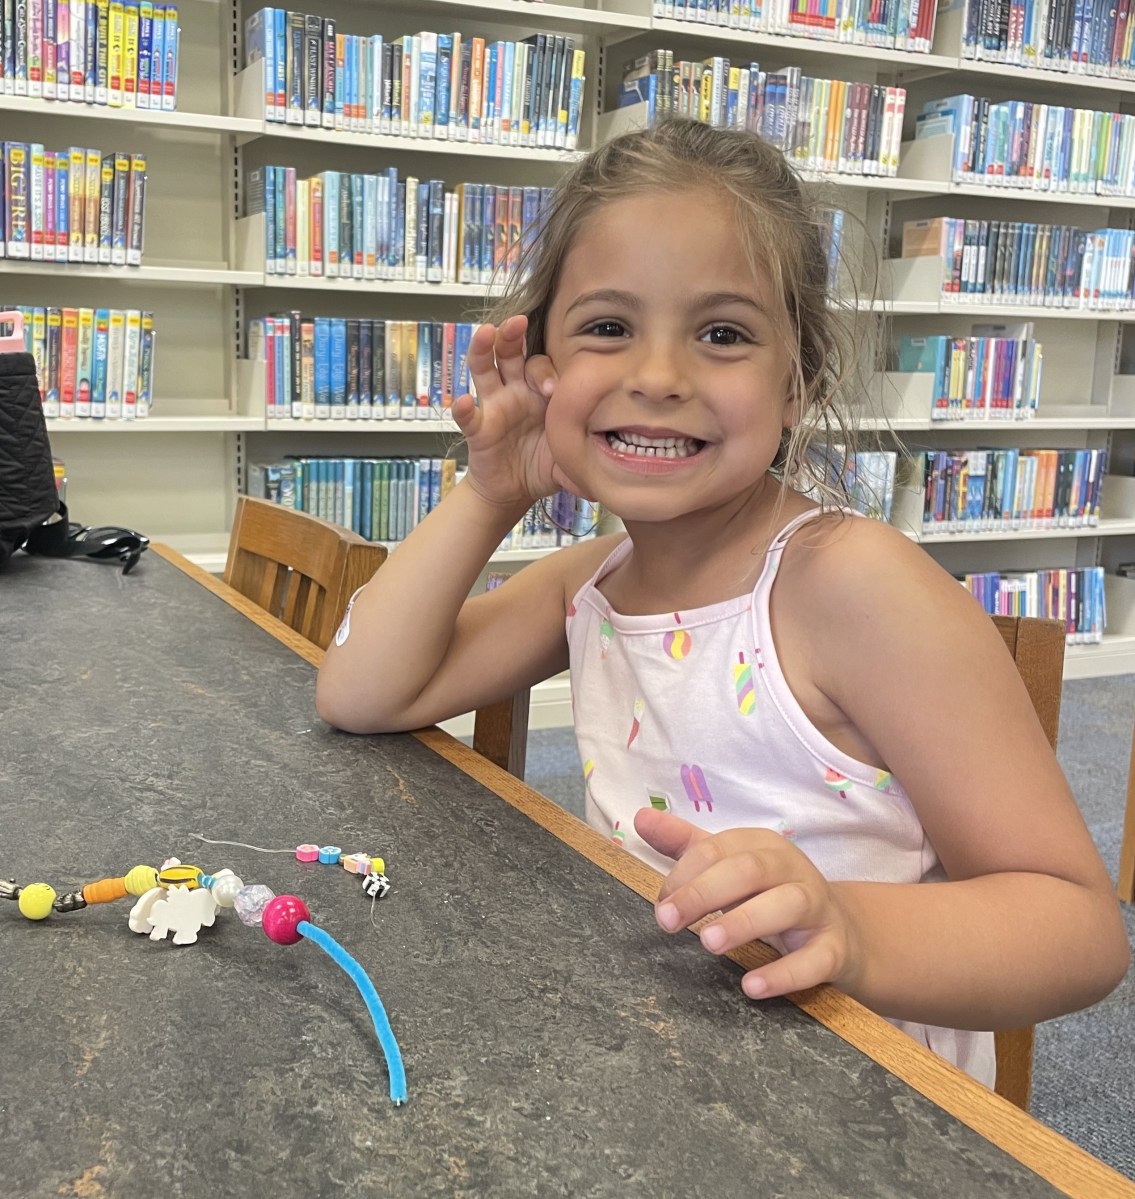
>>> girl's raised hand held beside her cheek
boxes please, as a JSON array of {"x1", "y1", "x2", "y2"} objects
[{"x1": 453, "y1": 317, "x2": 570, "y2": 506}]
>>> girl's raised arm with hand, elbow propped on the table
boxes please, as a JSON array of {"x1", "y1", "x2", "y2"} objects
[{"x1": 315, "y1": 318, "x2": 599, "y2": 733}]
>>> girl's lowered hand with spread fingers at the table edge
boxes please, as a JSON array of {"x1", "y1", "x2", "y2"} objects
[{"x1": 634, "y1": 808, "x2": 858, "y2": 999}]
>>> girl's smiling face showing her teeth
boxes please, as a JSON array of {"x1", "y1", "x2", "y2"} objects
[{"x1": 545, "y1": 189, "x2": 792, "y2": 522}]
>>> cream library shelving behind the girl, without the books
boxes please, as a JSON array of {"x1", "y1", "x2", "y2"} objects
[{"x1": 0, "y1": 0, "x2": 1135, "y2": 731}]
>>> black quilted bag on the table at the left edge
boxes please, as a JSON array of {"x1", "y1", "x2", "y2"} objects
[{"x1": 0, "y1": 328, "x2": 59, "y2": 566}]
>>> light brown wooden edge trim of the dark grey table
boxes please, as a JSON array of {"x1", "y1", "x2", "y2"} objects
[{"x1": 150, "y1": 543, "x2": 1135, "y2": 1199}]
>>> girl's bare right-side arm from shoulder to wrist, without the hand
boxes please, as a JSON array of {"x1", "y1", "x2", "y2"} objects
[{"x1": 809, "y1": 520, "x2": 1129, "y2": 1029}]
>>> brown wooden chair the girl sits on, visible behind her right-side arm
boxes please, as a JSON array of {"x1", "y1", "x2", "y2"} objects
[{"x1": 994, "y1": 616, "x2": 1064, "y2": 1111}]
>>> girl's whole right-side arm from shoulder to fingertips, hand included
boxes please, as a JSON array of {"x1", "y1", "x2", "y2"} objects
[{"x1": 635, "y1": 519, "x2": 1129, "y2": 1029}]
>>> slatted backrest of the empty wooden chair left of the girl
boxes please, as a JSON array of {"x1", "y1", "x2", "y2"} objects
[{"x1": 224, "y1": 495, "x2": 386, "y2": 650}]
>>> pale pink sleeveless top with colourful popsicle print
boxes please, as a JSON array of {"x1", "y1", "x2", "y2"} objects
[{"x1": 567, "y1": 512, "x2": 995, "y2": 1086}]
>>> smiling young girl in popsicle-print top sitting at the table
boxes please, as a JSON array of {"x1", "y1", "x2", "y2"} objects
[{"x1": 316, "y1": 121, "x2": 1128, "y2": 1085}]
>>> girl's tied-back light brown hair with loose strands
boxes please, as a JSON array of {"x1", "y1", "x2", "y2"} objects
[{"x1": 489, "y1": 120, "x2": 859, "y2": 504}]
